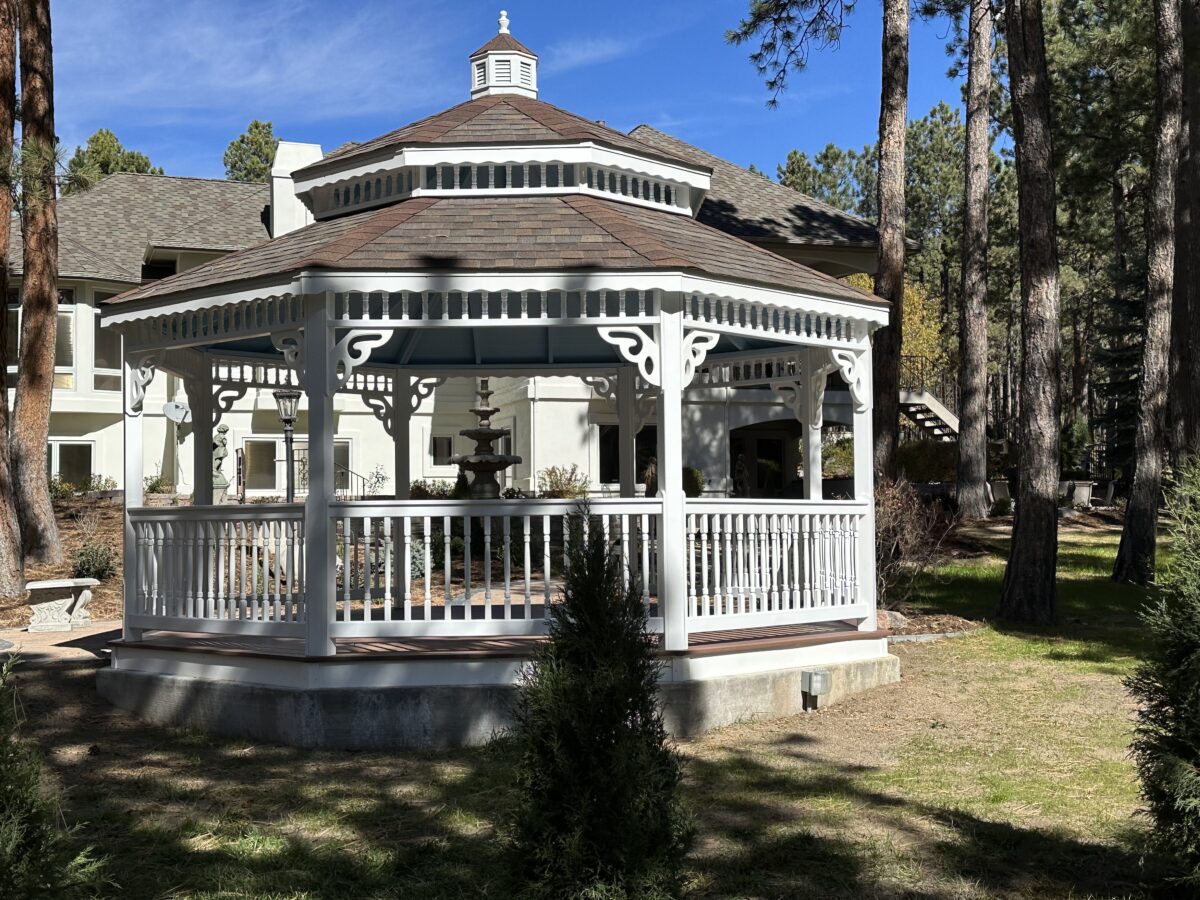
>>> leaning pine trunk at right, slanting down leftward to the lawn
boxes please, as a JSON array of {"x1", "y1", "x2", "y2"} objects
[{"x1": 1112, "y1": 0, "x2": 1183, "y2": 584}]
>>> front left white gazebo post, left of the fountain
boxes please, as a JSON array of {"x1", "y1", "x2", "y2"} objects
[{"x1": 302, "y1": 294, "x2": 336, "y2": 656}]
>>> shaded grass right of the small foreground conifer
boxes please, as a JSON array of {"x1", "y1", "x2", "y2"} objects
[{"x1": 689, "y1": 734, "x2": 1188, "y2": 900}]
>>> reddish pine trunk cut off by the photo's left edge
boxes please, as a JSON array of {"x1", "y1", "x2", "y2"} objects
[{"x1": 0, "y1": 0, "x2": 25, "y2": 599}]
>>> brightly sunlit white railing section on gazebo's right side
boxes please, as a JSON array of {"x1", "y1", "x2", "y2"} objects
[{"x1": 686, "y1": 499, "x2": 870, "y2": 631}]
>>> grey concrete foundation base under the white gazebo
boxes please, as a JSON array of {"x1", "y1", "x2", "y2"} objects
[{"x1": 97, "y1": 641, "x2": 900, "y2": 750}]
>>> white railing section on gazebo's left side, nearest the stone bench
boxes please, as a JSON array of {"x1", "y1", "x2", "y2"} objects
[{"x1": 125, "y1": 504, "x2": 305, "y2": 635}]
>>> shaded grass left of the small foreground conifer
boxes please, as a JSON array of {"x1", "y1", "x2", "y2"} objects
[{"x1": 18, "y1": 667, "x2": 510, "y2": 900}]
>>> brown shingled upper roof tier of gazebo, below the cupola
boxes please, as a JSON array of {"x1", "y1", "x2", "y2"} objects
[{"x1": 293, "y1": 94, "x2": 708, "y2": 180}]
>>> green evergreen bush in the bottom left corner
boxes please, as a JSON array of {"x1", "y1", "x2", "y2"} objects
[{"x1": 0, "y1": 656, "x2": 100, "y2": 898}]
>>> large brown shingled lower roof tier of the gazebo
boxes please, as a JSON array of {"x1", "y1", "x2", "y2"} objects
[{"x1": 109, "y1": 194, "x2": 882, "y2": 304}]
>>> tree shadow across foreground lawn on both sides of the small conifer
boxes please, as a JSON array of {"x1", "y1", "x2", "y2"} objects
[{"x1": 19, "y1": 667, "x2": 1180, "y2": 900}]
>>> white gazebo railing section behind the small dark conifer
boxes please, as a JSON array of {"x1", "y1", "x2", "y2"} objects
[{"x1": 330, "y1": 498, "x2": 662, "y2": 637}]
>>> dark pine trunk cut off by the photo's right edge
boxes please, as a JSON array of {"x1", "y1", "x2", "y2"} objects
[{"x1": 1176, "y1": 0, "x2": 1200, "y2": 455}]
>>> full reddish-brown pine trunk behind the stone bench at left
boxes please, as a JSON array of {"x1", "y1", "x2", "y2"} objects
[{"x1": 12, "y1": 0, "x2": 62, "y2": 563}]
